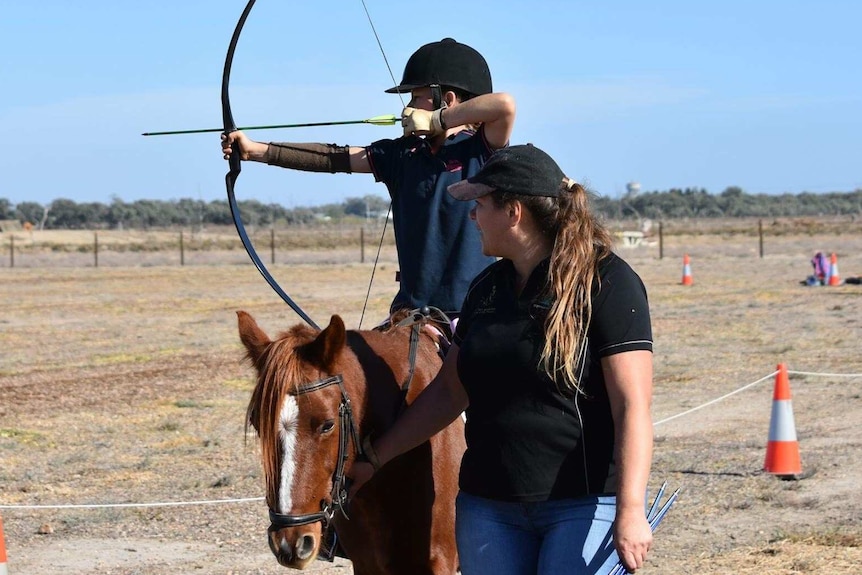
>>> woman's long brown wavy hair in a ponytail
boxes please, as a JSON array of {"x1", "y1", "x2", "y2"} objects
[{"x1": 492, "y1": 179, "x2": 613, "y2": 392}]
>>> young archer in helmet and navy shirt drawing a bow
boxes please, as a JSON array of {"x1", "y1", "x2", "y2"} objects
[{"x1": 222, "y1": 38, "x2": 515, "y2": 316}]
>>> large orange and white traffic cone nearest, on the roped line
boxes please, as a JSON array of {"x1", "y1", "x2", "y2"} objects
[{"x1": 763, "y1": 363, "x2": 802, "y2": 479}]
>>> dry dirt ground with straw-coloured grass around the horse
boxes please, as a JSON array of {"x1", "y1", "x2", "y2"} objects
[{"x1": 0, "y1": 233, "x2": 862, "y2": 575}]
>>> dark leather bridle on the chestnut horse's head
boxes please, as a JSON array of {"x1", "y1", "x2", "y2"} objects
[{"x1": 268, "y1": 375, "x2": 363, "y2": 532}]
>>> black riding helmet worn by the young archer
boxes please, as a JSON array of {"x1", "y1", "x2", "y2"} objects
[{"x1": 386, "y1": 38, "x2": 493, "y2": 96}]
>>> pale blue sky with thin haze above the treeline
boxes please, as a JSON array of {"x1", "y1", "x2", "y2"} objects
[{"x1": 0, "y1": 0, "x2": 862, "y2": 207}]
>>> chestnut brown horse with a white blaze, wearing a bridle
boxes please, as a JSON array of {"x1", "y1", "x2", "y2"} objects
[{"x1": 237, "y1": 311, "x2": 465, "y2": 575}]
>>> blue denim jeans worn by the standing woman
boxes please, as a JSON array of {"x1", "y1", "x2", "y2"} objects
[{"x1": 455, "y1": 492, "x2": 617, "y2": 575}]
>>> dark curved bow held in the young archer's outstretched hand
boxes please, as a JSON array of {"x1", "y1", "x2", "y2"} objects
[{"x1": 221, "y1": 0, "x2": 320, "y2": 329}]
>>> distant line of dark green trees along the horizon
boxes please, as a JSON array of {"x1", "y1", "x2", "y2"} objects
[{"x1": 0, "y1": 187, "x2": 862, "y2": 230}]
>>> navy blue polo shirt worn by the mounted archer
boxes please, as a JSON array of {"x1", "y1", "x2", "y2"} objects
[{"x1": 366, "y1": 128, "x2": 494, "y2": 313}]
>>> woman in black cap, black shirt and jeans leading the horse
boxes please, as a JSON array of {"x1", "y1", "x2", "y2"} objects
[{"x1": 351, "y1": 145, "x2": 652, "y2": 575}]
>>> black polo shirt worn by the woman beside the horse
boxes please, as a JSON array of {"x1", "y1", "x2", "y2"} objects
[{"x1": 454, "y1": 255, "x2": 652, "y2": 501}]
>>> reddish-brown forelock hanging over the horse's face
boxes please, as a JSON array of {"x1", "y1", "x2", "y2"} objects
[{"x1": 246, "y1": 325, "x2": 316, "y2": 493}]
